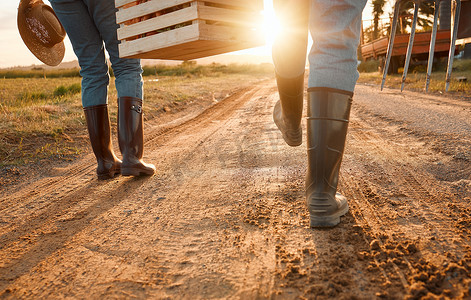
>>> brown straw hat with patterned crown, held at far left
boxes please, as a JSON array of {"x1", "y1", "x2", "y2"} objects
[{"x1": 17, "y1": 0, "x2": 65, "y2": 66}]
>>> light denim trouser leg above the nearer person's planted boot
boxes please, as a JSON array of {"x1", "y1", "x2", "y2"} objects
[{"x1": 308, "y1": 0, "x2": 366, "y2": 92}]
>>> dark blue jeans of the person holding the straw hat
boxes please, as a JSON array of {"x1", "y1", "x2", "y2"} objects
[{"x1": 50, "y1": 0, "x2": 143, "y2": 107}]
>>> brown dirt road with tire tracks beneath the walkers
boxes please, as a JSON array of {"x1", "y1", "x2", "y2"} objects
[{"x1": 0, "y1": 81, "x2": 471, "y2": 299}]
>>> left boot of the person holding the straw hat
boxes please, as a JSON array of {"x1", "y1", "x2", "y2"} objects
[{"x1": 83, "y1": 104, "x2": 121, "y2": 180}]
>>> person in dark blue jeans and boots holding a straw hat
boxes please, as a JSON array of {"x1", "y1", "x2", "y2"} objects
[{"x1": 18, "y1": 0, "x2": 155, "y2": 179}]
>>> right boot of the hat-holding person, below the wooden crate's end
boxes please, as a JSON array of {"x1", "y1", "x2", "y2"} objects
[{"x1": 118, "y1": 97, "x2": 155, "y2": 176}]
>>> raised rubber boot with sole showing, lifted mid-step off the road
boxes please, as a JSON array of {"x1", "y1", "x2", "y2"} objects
[{"x1": 273, "y1": 74, "x2": 304, "y2": 147}]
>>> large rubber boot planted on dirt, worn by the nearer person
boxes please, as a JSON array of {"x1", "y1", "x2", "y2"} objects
[{"x1": 306, "y1": 88, "x2": 353, "y2": 227}]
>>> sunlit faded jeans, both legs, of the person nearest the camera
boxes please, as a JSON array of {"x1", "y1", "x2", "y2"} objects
[{"x1": 273, "y1": 0, "x2": 366, "y2": 92}]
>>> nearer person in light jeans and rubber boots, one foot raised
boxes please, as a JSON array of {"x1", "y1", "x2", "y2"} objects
[{"x1": 273, "y1": 0, "x2": 366, "y2": 227}]
